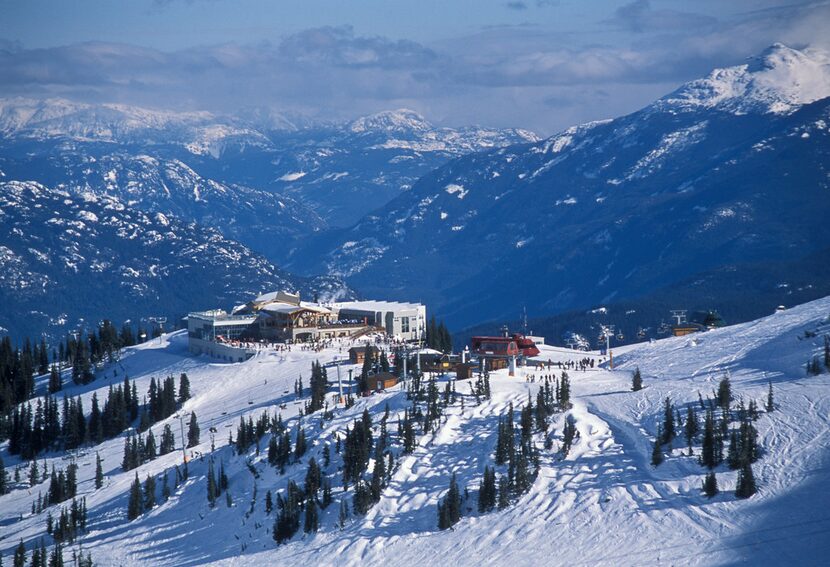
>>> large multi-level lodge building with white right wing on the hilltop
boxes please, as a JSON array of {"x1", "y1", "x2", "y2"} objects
[{"x1": 187, "y1": 291, "x2": 427, "y2": 362}]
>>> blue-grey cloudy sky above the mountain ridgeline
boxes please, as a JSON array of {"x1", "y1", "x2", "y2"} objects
[{"x1": 0, "y1": 0, "x2": 830, "y2": 134}]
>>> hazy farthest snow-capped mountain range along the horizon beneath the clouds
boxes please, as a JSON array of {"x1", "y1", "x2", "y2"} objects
[{"x1": 0, "y1": 98, "x2": 537, "y2": 227}]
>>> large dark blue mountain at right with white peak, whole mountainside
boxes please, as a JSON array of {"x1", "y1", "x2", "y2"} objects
[{"x1": 286, "y1": 45, "x2": 830, "y2": 327}]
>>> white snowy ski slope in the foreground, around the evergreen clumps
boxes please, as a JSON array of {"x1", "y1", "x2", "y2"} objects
[{"x1": 0, "y1": 297, "x2": 830, "y2": 565}]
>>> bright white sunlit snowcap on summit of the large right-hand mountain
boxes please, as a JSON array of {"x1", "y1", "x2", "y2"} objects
[{"x1": 655, "y1": 43, "x2": 830, "y2": 114}]
